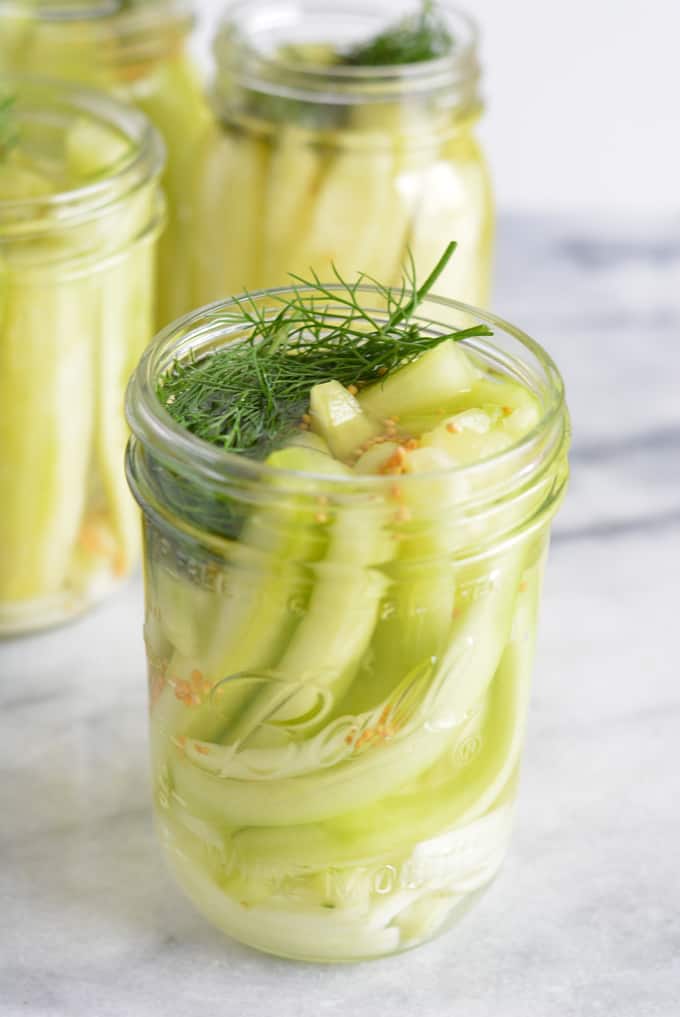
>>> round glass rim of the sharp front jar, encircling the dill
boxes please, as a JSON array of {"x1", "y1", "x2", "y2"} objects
[{"x1": 126, "y1": 285, "x2": 568, "y2": 504}]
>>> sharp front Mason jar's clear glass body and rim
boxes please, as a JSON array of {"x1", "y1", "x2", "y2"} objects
[{"x1": 127, "y1": 286, "x2": 568, "y2": 961}]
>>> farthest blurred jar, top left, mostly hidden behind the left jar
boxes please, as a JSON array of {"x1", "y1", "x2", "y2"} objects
[{"x1": 0, "y1": 0, "x2": 209, "y2": 326}]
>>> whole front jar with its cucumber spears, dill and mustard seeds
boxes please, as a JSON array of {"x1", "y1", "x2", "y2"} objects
[{"x1": 127, "y1": 250, "x2": 568, "y2": 961}]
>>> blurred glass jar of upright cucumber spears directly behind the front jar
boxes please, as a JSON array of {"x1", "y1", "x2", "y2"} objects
[{"x1": 193, "y1": 0, "x2": 493, "y2": 306}]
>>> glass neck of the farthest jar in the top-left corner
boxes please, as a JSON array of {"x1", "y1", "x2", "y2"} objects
[{"x1": 0, "y1": 0, "x2": 195, "y2": 65}]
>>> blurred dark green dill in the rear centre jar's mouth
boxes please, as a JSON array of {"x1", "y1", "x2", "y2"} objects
[{"x1": 342, "y1": 0, "x2": 453, "y2": 67}]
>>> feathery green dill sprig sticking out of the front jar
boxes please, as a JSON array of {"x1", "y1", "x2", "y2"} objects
[{"x1": 158, "y1": 243, "x2": 492, "y2": 458}]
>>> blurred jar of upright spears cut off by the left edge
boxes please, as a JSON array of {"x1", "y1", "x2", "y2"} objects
[{"x1": 0, "y1": 75, "x2": 163, "y2": 634}]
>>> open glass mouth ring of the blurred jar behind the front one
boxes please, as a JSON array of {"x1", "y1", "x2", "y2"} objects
[{"x1": 214, "y1": 0, "x2": 480, "y2": 107}]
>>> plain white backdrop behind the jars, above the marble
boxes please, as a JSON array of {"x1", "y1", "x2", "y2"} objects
[{"x1": 196, "y1": 0, "x2": 680, "y2": 216}]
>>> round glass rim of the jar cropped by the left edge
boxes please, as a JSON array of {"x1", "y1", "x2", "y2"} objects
[{"x1": 0, "y1": 74, "x2": 165, "y2": 235}]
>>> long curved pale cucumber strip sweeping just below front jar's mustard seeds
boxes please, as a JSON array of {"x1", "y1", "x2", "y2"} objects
[{"x1": 170, "y1": 551, "x2": 521, "y2": 826}]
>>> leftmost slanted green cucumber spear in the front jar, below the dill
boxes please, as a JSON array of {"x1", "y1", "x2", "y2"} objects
[{"x1": 151, "y1": 445, "x2": 348, "y2": 756}]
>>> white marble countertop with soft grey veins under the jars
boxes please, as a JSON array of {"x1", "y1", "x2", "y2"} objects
[{"x1": 0, "y1": 216, "x2": 680, "y2": 1017}]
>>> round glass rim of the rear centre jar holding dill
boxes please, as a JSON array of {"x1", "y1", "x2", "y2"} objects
[{"x1": 213, "y1": 0, "x2": 480, "y2": 107}]
